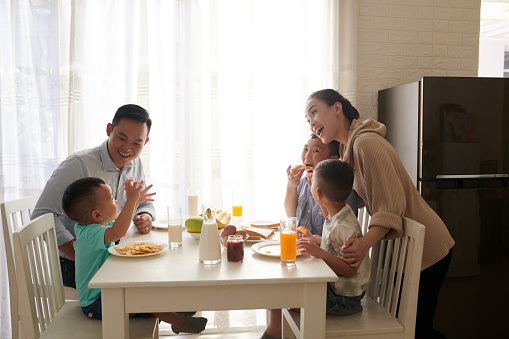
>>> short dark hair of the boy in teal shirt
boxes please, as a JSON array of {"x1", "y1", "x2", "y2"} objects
[{"x1": 62, "y1": 177, "x2": 106, "y2": 225}]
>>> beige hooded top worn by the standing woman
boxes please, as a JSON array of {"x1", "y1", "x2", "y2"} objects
[{"x1": 340, "y1": 119, "x2": 454, "y2": 270}]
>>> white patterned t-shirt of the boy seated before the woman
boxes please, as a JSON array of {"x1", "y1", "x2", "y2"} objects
[{"x1": 320, "y1": 205, "x2": 371, "y2": 297}]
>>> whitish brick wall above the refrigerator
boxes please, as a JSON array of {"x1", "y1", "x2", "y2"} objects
[{"x1": 354, "y1": 0, "x2": 481, "y2": 119}]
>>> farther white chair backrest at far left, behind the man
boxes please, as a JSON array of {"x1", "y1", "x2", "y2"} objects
[{"x1": 0, "y1": 196, "x2": 39, "y2": 338}]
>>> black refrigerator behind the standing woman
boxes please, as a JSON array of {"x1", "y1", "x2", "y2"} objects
[{"x1": 378, "y1": 77, "x2": 509, "y2": 338}]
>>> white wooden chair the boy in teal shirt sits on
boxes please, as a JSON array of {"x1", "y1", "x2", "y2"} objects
[{"x1": 13, "y1": 213, "x2": 159, "y2": 338}]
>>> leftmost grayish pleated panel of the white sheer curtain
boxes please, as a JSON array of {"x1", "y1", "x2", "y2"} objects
[{"x1": 0, "y1": 1, "x2": 67, "y2": 338}]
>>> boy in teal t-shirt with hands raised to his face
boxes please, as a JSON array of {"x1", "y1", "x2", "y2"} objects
[{"x1": 62, "y1": 178, "x2": 207, "y2": 334}]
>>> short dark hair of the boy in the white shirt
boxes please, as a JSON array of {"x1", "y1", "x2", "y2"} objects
[{"x1": 313, "y1": 159, "x2": 353, "y2": 202}]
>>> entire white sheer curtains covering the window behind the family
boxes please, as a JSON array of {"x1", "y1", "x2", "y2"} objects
[{"x1": 0, "y1": 0, "x2": 342, "y2": 334}]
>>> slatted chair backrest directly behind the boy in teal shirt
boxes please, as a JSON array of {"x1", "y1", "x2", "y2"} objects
[{"x1": 13, "y1": 213, "x2": 66, "y2": 338}]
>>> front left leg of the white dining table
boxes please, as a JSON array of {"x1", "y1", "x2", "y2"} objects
[{"x1": 101, "y1": 288, "x2": 129, "y2": 339}]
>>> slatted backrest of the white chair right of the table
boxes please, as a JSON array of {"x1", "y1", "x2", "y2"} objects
[{"x1": 367, "y1": 218, "x2": 424, "y2": 335}]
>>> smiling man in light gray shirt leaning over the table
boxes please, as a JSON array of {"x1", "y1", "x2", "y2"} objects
[{"x1": 31, "y1": 104, "x2": 155, "y2": 288}]
